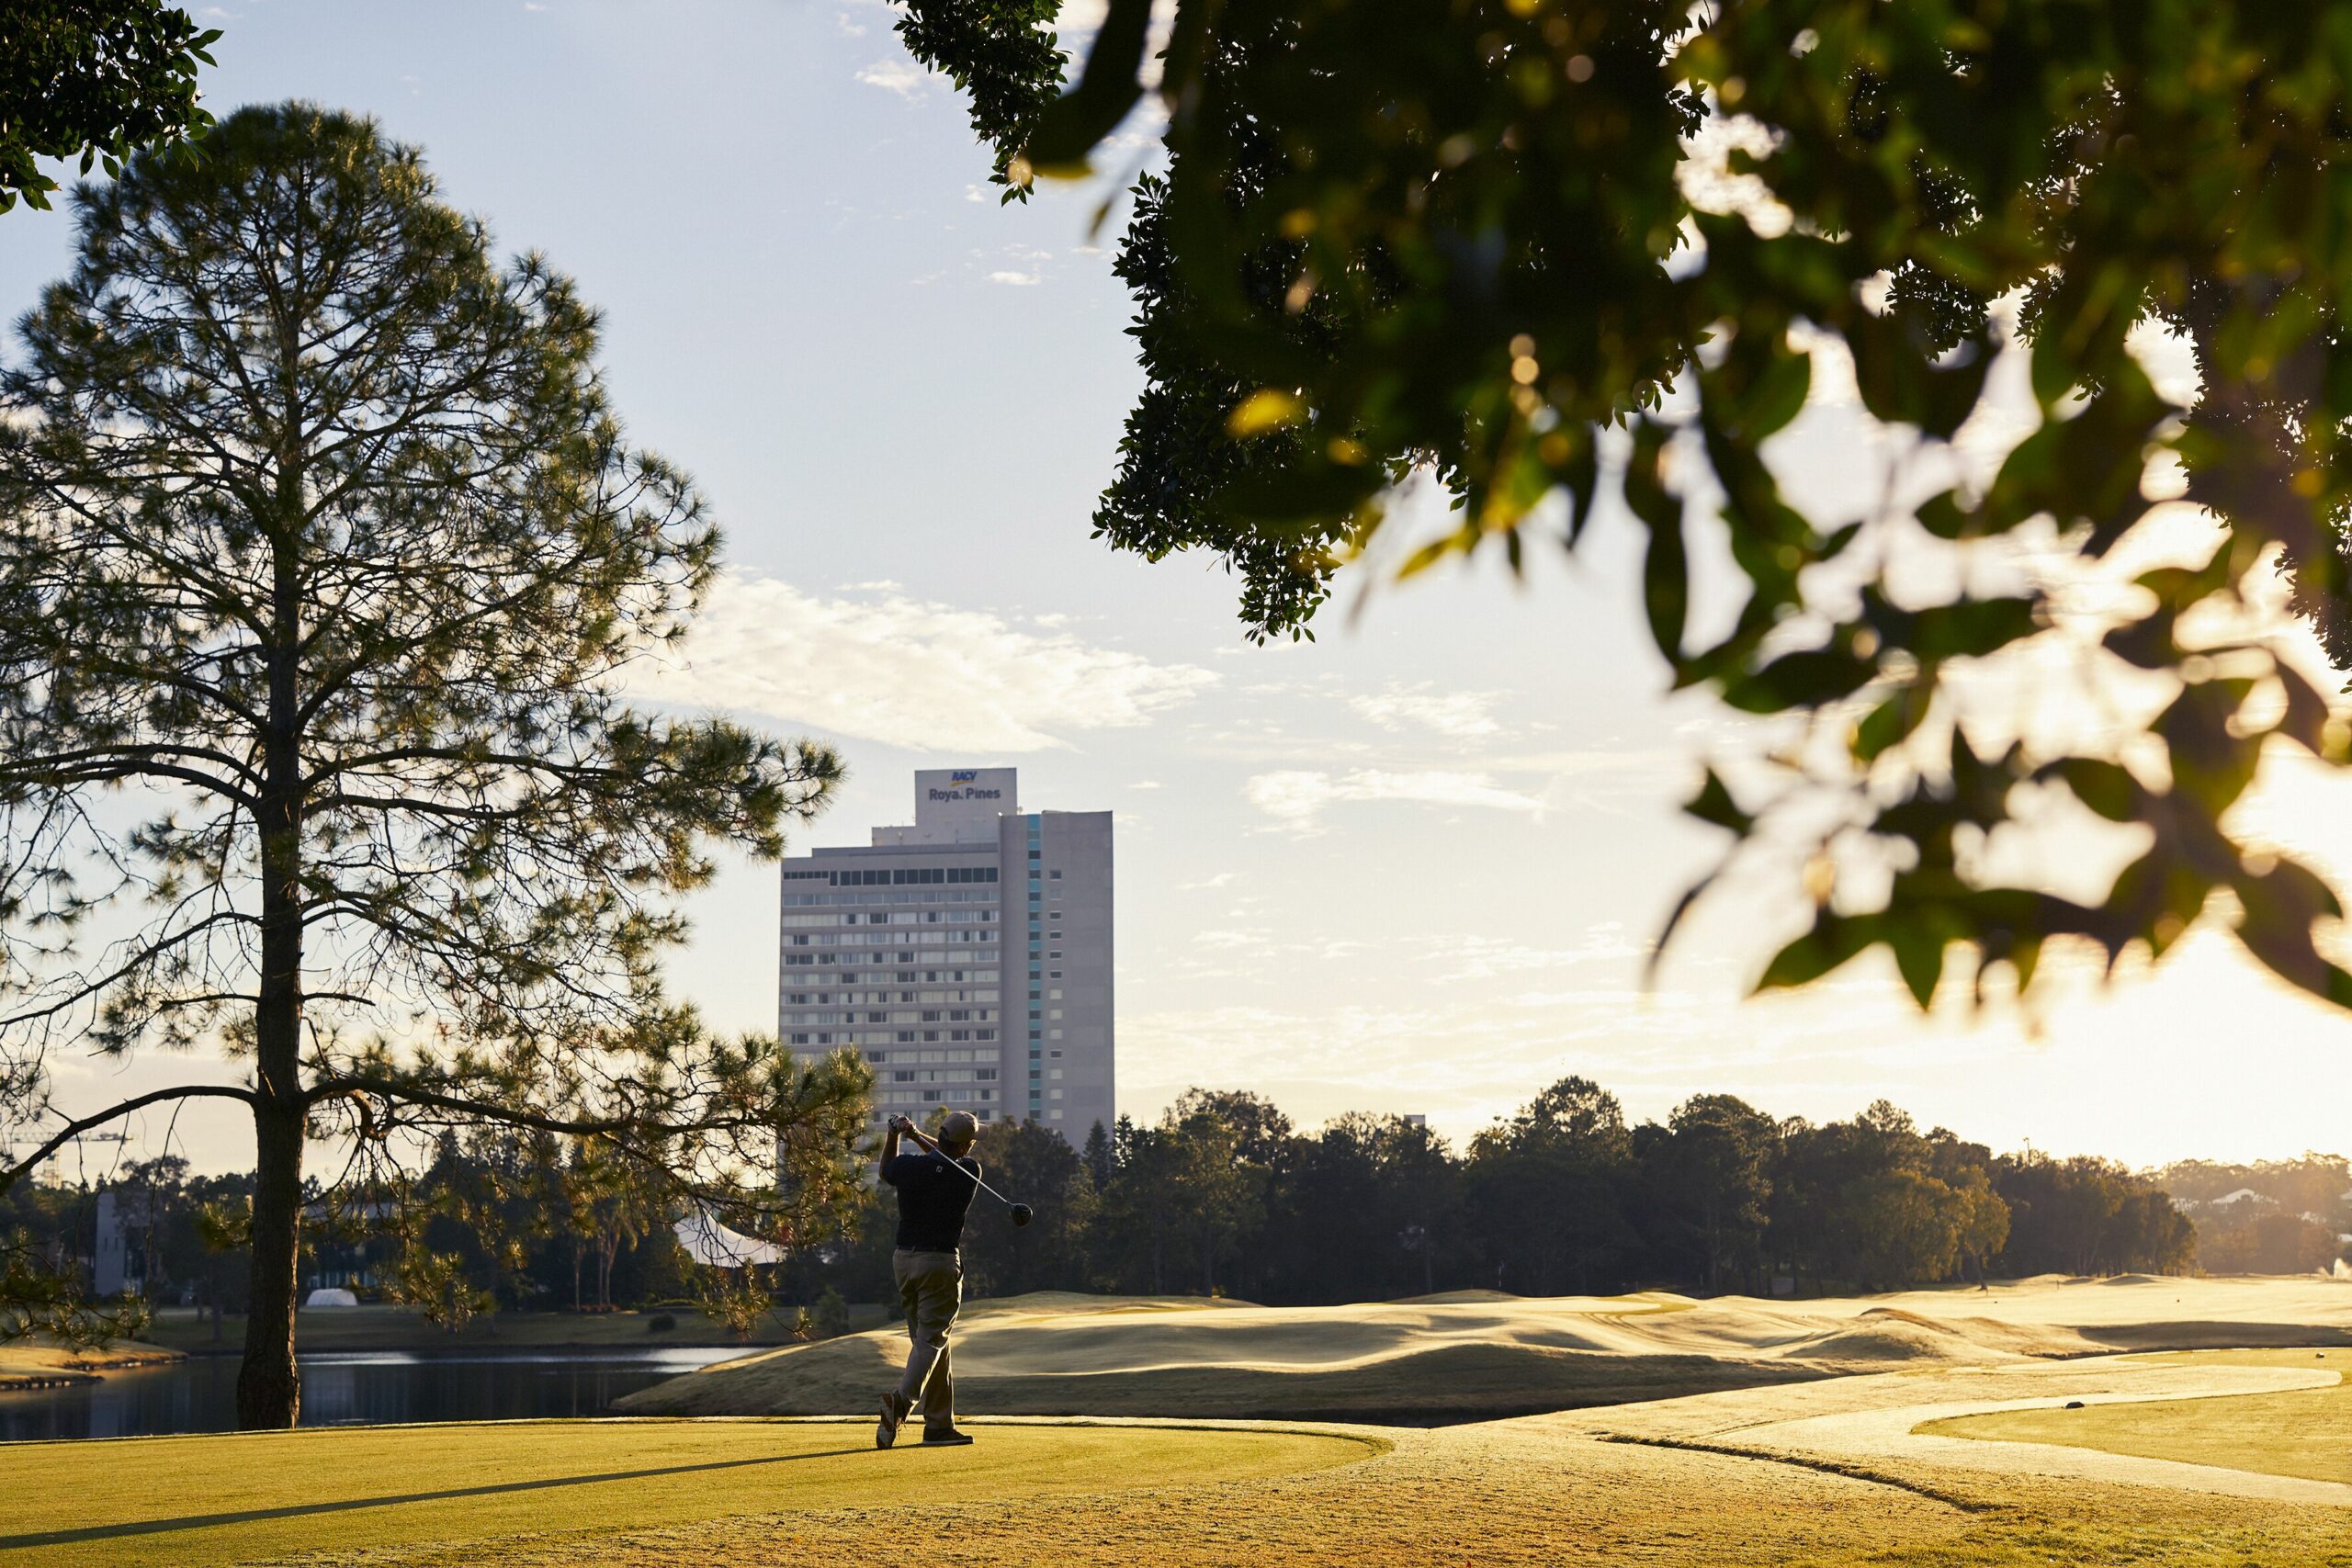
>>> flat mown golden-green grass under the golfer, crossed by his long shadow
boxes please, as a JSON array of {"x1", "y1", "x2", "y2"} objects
[{"x1": 0, "y1": 1420, "x2": 1376, "y2": 1568}]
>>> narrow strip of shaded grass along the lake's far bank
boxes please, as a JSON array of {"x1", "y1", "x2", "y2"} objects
[{"x1": 146, "y1": 1307, "x2": 882, "y2": 1354}]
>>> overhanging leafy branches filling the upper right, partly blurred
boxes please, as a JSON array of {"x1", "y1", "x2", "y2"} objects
[{"x1": 903, "y1": 0, "x2": 2352, "y2": 1006}]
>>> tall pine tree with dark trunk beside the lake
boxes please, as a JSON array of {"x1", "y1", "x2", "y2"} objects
[{"x1": 0, "y1": 104, "x2": 865, "y2": 1425}]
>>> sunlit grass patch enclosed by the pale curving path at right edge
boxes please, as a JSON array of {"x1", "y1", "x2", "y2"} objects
[{"x1": 1922, "y1": 1349, "x2": 2352, "y2": 1483}]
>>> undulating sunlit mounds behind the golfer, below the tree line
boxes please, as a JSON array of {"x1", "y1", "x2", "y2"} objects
[{"x1": 621, "y1": 1277, "x2": 2352, "y2": 1422}]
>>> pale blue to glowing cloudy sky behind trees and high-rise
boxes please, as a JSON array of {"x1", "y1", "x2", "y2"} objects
[{"x1": 0, "y1": 0, "x2": 2352, "y2": 1166}]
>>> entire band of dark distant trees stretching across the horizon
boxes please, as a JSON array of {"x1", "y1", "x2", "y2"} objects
[{"x1": 0, "y1": 1077, "x2": 2239, "y2": 1333}]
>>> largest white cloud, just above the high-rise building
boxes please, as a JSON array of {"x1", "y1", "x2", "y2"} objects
[{"x1": 630, "y1": 569, "x2": 1218, "y2": 752}]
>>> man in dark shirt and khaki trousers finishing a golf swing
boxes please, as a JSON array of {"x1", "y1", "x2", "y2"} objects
[{"x1": 875, "y1": 1112, "x2": 981, "y2": 1448}]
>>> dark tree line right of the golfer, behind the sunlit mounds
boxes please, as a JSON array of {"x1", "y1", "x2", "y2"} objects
[{"x1": 808, "y1": 1077, "x2": 2197, "y2": 1304}]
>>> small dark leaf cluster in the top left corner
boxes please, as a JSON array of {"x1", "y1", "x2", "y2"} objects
[{"x1": 0, "y1": 0, "x2": 221, "y2": 211}]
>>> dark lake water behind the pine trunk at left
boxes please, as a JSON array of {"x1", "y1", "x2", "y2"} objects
[{"x1": 0, "y1": 1345, "x2": 757, "y2": 1443}]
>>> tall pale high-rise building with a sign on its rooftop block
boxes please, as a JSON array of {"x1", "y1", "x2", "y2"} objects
[{"x1": 776, "y1": 769, "x2": 1114, "y2": 1143}]
